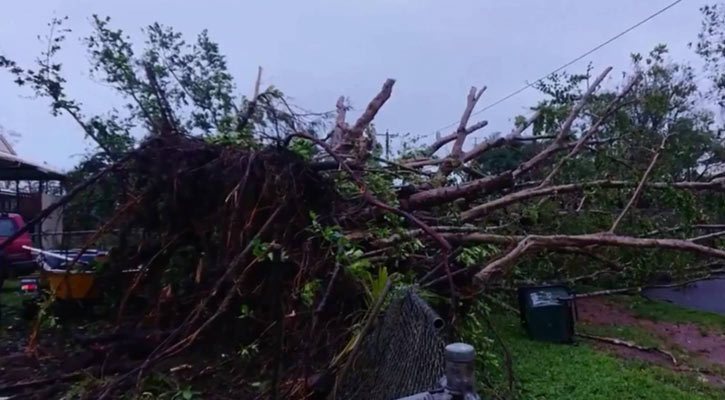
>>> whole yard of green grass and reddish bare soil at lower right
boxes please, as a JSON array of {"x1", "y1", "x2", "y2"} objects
[{"x1": 466, "y1": 296, "x2": 725, "y2": 400}]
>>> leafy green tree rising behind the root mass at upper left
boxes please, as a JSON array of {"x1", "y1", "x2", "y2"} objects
[{"x1": 0, "y1": 15, "x2": 324, "y2": 229}]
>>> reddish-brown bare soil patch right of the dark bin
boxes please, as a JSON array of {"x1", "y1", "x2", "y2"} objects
[{"x1": 577, "y1": 298, "x2": 725, "y2": 386}]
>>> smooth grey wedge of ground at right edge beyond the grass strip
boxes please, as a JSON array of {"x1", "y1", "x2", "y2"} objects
[{"x1": 642, "y1": 276, "x2": 725, "y2": 315}]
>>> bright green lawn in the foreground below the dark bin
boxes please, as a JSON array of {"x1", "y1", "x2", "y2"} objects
[{"x1": 464, "y1": 315, "x2": 725, "y2": 400}]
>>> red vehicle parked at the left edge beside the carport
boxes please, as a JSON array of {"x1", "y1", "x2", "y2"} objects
[{"x1": 0, "y1": 213, "x2": 37, "y2": 287}]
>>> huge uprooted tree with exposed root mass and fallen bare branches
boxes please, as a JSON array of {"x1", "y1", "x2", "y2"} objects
[{"x1": 0, "y1": 8, "x2": 725, "y2": 398}]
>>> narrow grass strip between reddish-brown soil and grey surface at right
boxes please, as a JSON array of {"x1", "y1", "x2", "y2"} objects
[{"x1": 611, "y1": 296, "x2": 725, "y2": 332}]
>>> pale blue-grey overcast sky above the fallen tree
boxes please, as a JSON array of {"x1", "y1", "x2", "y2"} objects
[{"x1": 0, "y1": 0, "x2": 709, "y2": 169}]
